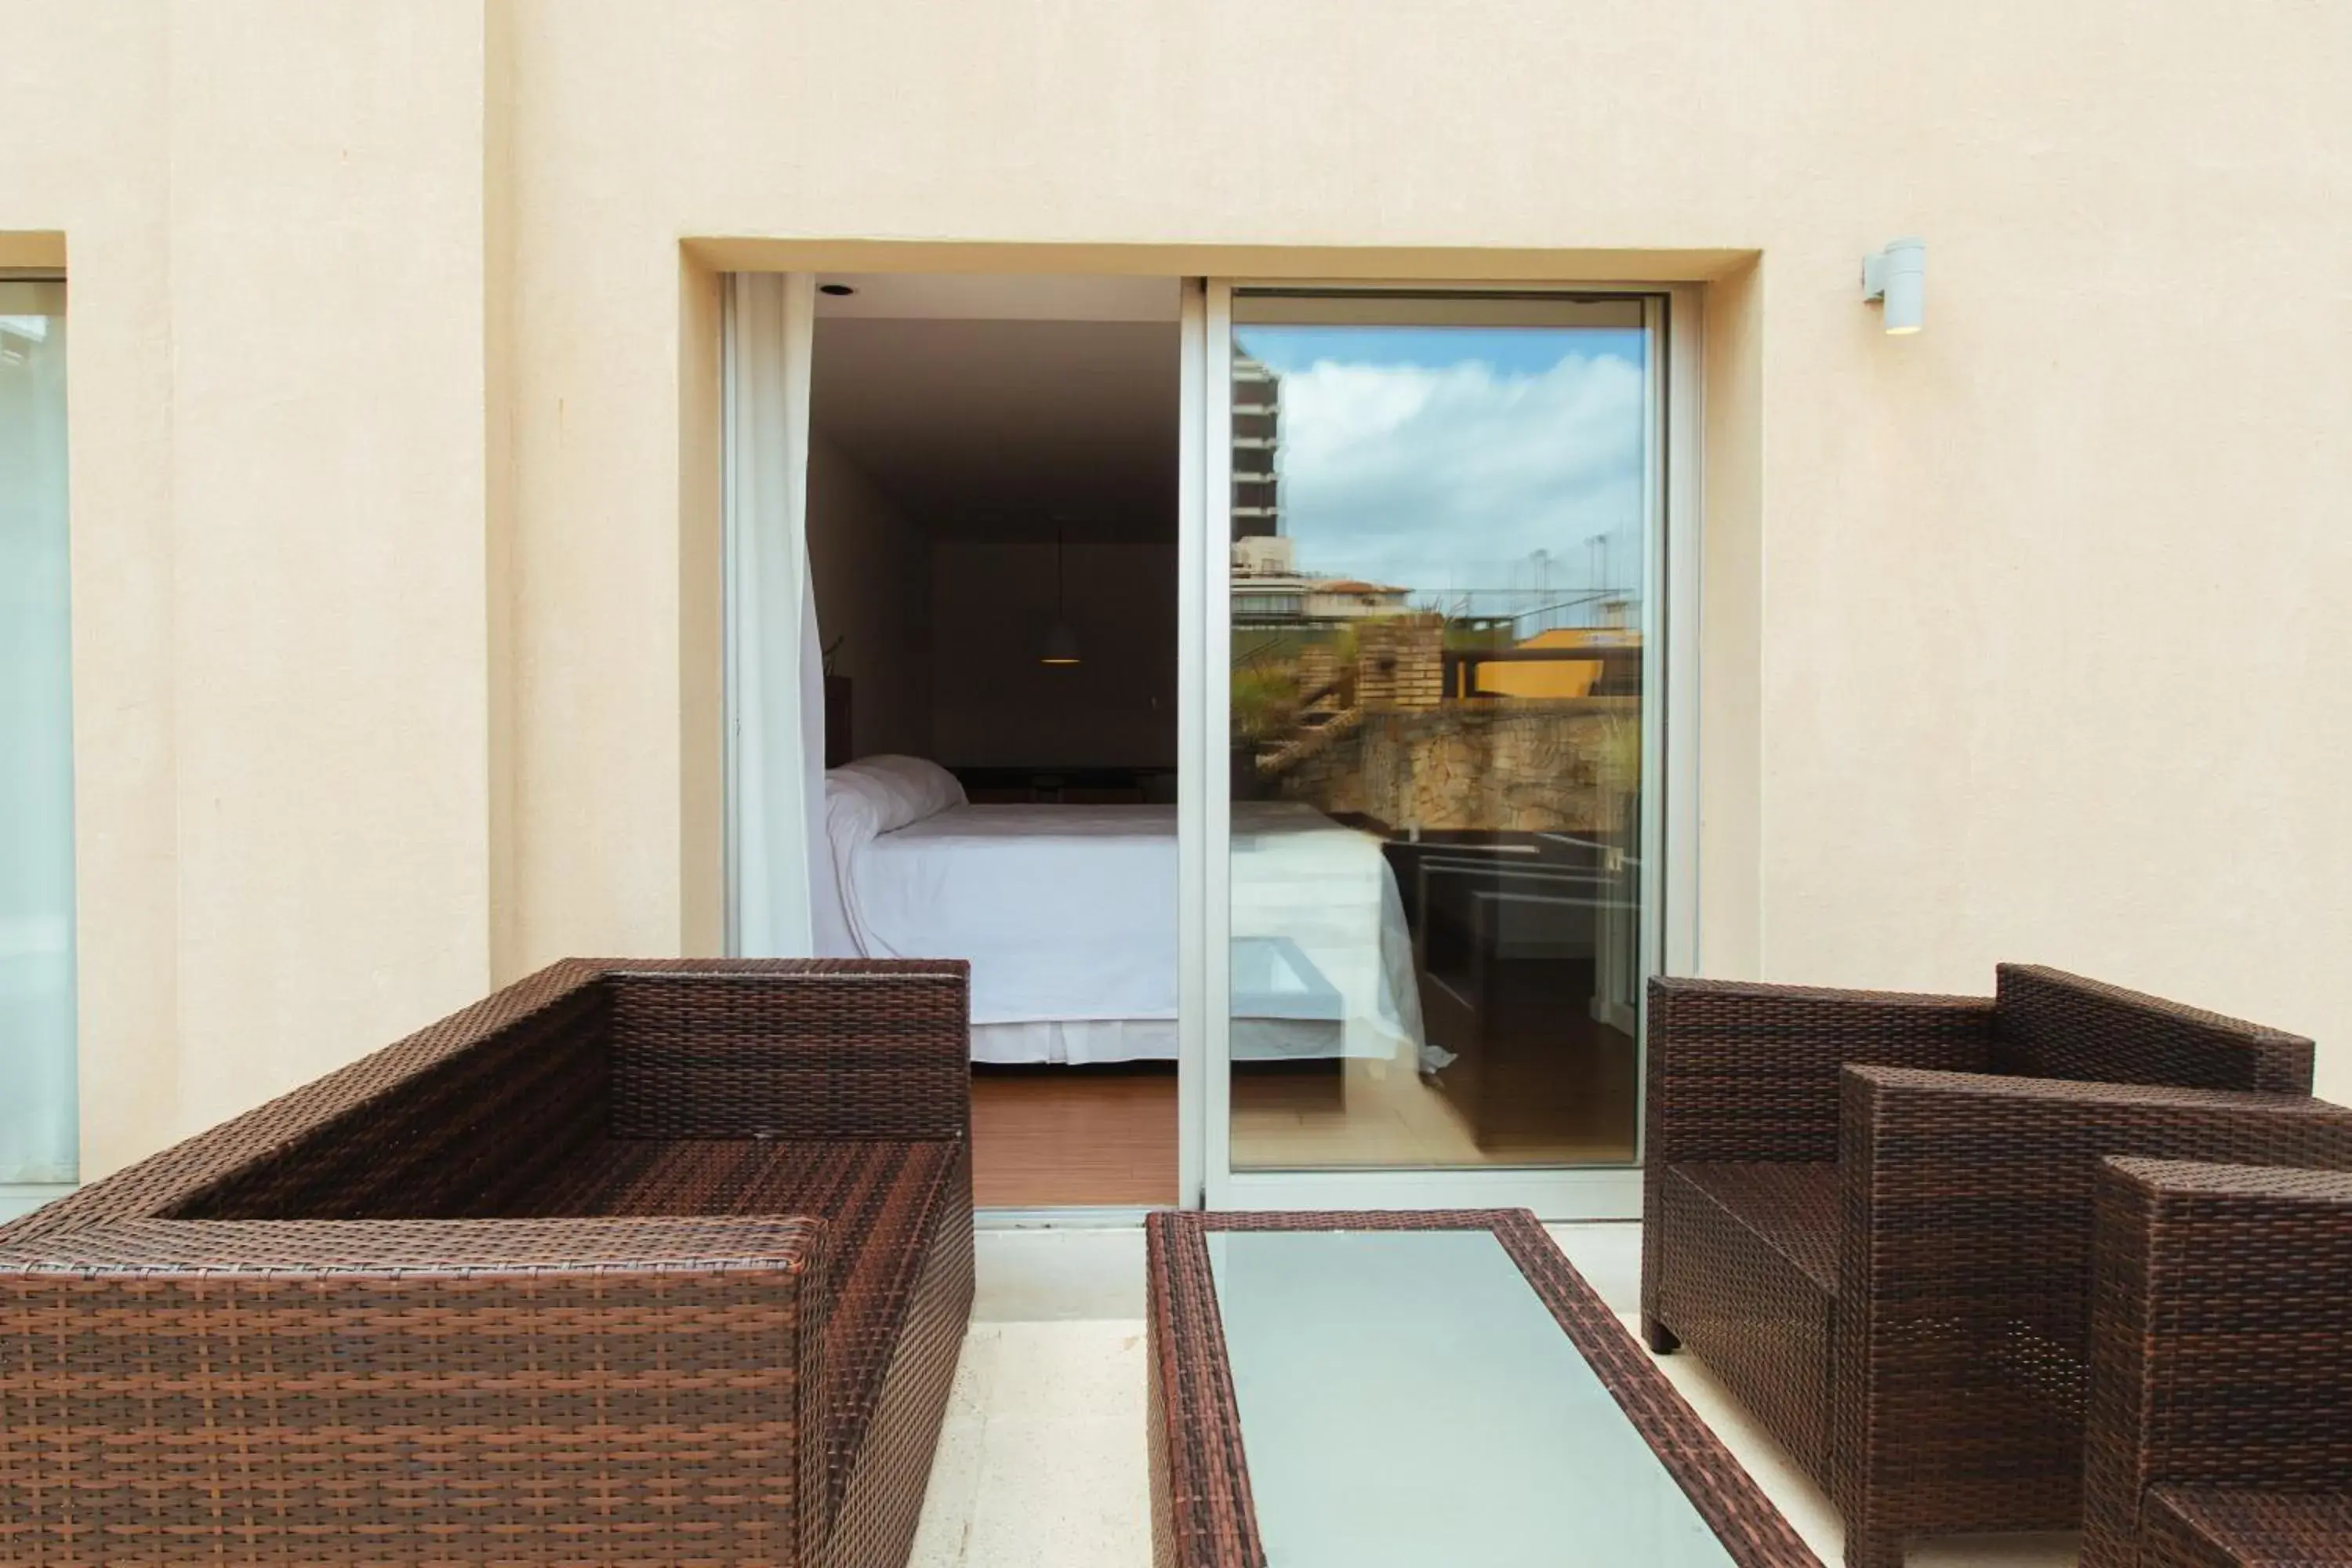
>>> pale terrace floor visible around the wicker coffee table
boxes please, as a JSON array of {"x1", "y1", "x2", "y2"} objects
[{"x1": 915, "y1": 1225, "x2": 2074, "y2": 1568}]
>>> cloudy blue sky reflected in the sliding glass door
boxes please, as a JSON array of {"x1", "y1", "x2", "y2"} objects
[{"x1": 1277, "y1": 353, "x2": 1644, "y2": 611}]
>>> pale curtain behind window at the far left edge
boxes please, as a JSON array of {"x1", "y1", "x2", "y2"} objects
[{"x1": 0, "y1": 280, "x2": 78, "y2": 1189}]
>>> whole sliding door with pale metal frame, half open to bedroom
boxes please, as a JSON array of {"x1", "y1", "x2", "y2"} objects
[{"x1": 727, "y1": 275, "x2": 1698, "y2": 1218}]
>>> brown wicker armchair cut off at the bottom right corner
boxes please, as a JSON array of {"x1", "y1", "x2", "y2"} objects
[{"x1": 2082, "y1": 1159, "x2": 2352, "y2": 1568}]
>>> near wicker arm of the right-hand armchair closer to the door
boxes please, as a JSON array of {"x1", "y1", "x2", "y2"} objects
[{"x1": 1830, "y1": 1067, "x2": 2352, "y2": 1561}]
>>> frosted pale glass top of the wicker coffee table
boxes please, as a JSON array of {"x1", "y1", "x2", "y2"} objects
[{"x1": 1207, "y1": 1229, "x2": 1731, "y2": 1568}]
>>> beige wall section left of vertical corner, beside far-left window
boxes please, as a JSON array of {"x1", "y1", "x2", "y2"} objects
[{"x1": 0, "y1": 0, "x2": 496, "y2": 1173}]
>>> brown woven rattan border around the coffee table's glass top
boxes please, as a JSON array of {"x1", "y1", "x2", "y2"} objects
[{"x1": 1145, "y1": 1208, "x2": 1820, "y2": 1568}]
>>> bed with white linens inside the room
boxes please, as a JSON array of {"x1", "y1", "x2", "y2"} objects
[{"x1": 816, "y1": 757, "x2": 1423, "y2": 1065}]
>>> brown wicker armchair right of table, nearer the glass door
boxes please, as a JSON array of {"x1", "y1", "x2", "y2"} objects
[{"x1": 1642, "y1": 966, "x2": 2352, "y2": 1568}]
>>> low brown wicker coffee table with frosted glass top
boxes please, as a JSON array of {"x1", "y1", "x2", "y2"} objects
[{"x1": 1145, "y1": 1208, "x2": 1820, "y2": 1568}]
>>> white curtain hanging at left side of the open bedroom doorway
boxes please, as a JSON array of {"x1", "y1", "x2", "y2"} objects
[{"x1": 727, "y1": 273, "x2": 837, "y2": 956}]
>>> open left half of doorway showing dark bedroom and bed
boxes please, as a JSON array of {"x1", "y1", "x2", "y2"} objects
[{"x1": 807, "y1": 275, "x2": 1181, "y2": 1208}]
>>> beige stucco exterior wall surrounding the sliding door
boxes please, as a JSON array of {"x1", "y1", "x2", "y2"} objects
[{"x1": 0, "y1": 0, "x2": 2352, "y2": 1168}]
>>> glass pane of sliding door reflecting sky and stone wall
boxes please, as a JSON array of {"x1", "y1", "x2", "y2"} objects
[{"x1": 1211, "y1": 289, "x2": 1661, "y2": 1173}]
